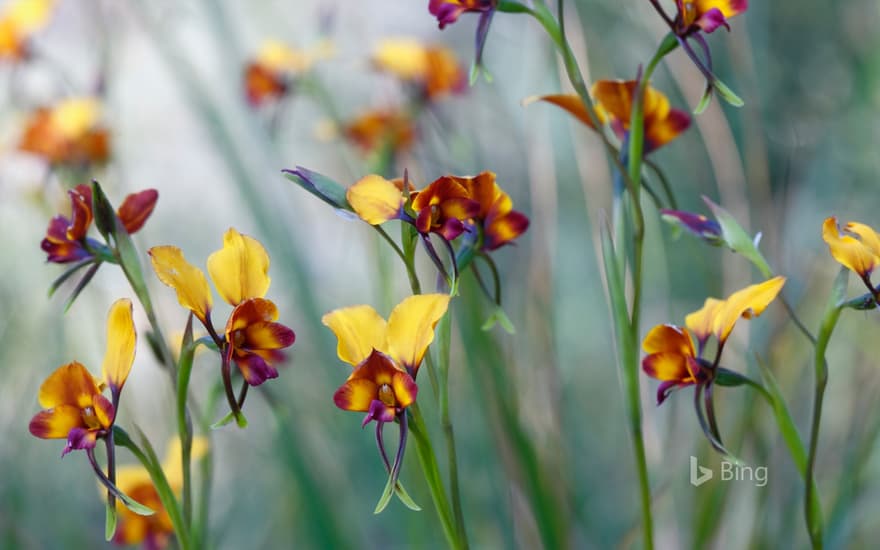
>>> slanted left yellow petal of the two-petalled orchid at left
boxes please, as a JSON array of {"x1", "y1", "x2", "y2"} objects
[{"x1": 148, "y1": 246, "x2": 213, "y2": 324}]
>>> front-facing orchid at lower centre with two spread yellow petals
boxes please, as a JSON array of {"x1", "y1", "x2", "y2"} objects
[{"x1": 321, "y1": 294, "x2": 450, "y2": 508}]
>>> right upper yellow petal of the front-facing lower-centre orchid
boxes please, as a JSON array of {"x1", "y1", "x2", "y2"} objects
[{"x1": 387, "y1": 294, "x2": 449, "y2": 370}]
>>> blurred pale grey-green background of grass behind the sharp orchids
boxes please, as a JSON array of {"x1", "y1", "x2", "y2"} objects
[{"x1": 0, "y1": 0, "x2": 880, "y2": 548}]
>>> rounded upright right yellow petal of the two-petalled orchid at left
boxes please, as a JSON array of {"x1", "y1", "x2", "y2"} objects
[{"x1": 208, "y1": 228, "x2": 271, "y2": 306}]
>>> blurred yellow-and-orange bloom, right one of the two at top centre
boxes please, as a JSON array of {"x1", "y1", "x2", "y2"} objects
[{"x1": 373, "y1": 38, "x2": 466, "y2": 100}]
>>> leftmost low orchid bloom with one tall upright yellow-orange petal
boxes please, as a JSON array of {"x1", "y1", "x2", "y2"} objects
[{"x1": 30, "y1": 299, "x2": 137, "y2": 456}]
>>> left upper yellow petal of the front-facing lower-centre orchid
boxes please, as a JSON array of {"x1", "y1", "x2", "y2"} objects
[{"x1": 321, "y1": 305, "x2": 386, "y2": 366}]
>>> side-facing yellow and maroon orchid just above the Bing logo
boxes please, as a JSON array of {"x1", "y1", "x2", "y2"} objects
[{"x1": 642, "y1": 277, "x2": 785, "y2": 452}]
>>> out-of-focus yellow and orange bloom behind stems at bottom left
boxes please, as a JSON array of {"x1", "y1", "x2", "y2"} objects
[{"x1": 113, "y1": 437, "x2": 208, "y2": 550}]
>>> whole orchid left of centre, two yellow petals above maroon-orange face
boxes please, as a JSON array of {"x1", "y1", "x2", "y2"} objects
[{"x1": 149, "y1": 228, "x2": 295, "y2": 423}]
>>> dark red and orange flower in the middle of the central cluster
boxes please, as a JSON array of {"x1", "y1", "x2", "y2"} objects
[{"x1": 412, "y1": 176, "x2": 480, "y2": 241}]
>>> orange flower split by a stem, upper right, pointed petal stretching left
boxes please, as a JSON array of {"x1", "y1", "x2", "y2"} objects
[{"x1": 526, "y1": 80, "x2": 691, "y2": 155}]
